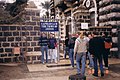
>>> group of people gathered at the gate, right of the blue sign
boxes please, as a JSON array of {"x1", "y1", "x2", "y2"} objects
[{"x1": 64, "y1": 31, "x2": 112, "y2": 77}]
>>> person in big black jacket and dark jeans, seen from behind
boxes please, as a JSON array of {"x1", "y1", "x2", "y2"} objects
[{"x1": 89, "y1": 32, "x2": 105, "y2": 77}]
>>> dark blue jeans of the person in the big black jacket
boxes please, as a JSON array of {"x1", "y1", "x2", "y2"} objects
[{"x1": 93, "y1": 56, "x2": 104, "y2": 75}]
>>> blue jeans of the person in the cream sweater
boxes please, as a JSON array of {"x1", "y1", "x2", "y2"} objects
[{"x1": 76, "y1": 52, "x2": 86, "y2": 75}]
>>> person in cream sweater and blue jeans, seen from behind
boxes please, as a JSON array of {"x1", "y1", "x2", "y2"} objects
[{"x1": 74, "y1": 31, "x2": 87, "y2": 75}]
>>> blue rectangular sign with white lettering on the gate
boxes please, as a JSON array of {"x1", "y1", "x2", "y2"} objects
[{"x1": 40, "y1": 22, "x2": 59, "y2": 32}]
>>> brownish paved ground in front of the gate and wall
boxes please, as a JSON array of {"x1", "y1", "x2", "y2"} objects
[{"x1": 0, "y1": 58, "x2": 120, "y2": 80}]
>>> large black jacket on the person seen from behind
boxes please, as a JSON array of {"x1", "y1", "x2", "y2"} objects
[{"x1": 89, "y1": 37, "x2": 105, "y2": 58}]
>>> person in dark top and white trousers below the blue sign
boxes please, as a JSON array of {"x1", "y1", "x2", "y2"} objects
[{"x1": 48, "y1": 33, "x2": 57, "y2": 63}]
